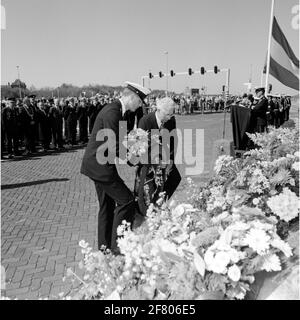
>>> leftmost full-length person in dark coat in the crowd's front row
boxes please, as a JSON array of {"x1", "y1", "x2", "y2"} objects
[{"x1": 2, "y1": 98, "x2": 20, "y2": 158}]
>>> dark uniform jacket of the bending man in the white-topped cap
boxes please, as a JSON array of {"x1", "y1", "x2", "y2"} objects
[{"x1": 80, "y1": 100, "x2": 122, "y2": 182}]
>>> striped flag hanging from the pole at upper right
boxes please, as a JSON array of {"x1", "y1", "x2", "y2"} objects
[{"x1": 263, "y1": 17, "x2": 299, "y2": 90}]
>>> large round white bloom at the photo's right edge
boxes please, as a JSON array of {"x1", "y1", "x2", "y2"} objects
[{"x1": 267, "y1": 188, "x2": 299, "y2": 222}]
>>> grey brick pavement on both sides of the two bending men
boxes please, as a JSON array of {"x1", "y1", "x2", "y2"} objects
[{"x1": 1, "y1": 110, "x2": 296, "y2": 299}]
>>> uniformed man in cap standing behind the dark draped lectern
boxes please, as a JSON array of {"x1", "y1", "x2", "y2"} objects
[{"x1": 251, "y1": 87, "x2": 268, "y2": 133}]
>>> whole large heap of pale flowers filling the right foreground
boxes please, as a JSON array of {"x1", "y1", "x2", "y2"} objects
[{"x1": 63, "y1": 129, "x2": 299, "y2": 300}]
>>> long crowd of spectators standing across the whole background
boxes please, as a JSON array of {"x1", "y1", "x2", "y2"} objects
[{"x1": 1, "y1": 87, "x2": 291, "y2": 158}]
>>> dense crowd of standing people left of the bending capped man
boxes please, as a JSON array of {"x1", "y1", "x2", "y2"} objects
[{"x1": 1, "y1": 95, "x2": 113, "y2": 158}]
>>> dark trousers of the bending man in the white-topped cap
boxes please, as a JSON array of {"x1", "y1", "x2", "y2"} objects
[{"x1": 94, "y1": 178, "x2": 135, "y2": 253}]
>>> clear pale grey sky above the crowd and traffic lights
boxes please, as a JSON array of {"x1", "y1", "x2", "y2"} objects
[{"x1": 1, "y1": 0, "x2": 299, "y2": 94}]
